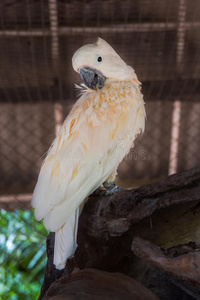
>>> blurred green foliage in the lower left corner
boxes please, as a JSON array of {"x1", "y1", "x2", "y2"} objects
[{"x1": 0, "y1": 210, "x2": 47, "y2": 300}]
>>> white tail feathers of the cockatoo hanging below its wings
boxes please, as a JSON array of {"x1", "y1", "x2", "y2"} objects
[{"x1": 53, "y1": 208, "x2": 79, "y2": 270}]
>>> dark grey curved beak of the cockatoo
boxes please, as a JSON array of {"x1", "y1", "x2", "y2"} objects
[{"x1": 79, "y1": 67, "x2": 106, "y2": 90}]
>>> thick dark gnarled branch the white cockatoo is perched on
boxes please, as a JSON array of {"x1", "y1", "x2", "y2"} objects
[{"x1": 39, "y1": 168, "x2": 200, "y2": 299}]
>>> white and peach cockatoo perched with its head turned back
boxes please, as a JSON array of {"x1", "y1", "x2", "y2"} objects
[{"x1": 31, "y1": 38, "x2": 146, "y2": 270}]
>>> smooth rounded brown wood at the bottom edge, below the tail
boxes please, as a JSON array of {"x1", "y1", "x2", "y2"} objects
[{"x1": 43, "y1": 269, "x2": 159, "y2": 300}]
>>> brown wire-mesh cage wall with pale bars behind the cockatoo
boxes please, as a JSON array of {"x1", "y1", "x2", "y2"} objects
[{"x1": 0, "y1": 0, "x2": 200, "y2": 210}]
